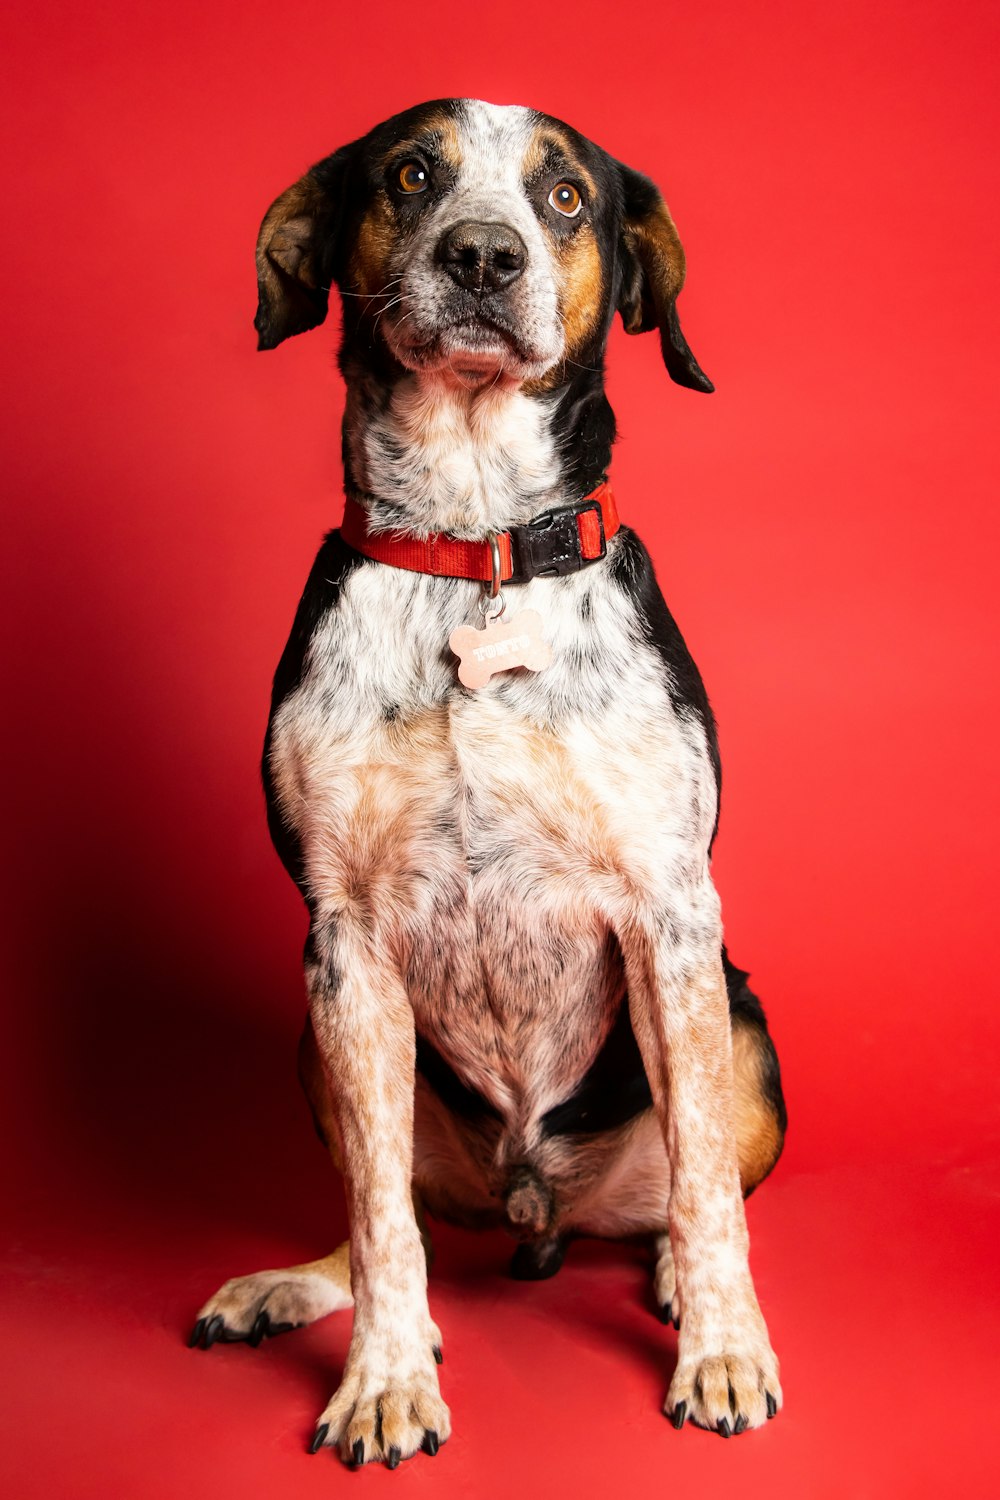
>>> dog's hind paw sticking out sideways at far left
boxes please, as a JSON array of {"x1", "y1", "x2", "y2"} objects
[{"x1": 187, "y1": 1271, "x2": 352, "y2": 1349}]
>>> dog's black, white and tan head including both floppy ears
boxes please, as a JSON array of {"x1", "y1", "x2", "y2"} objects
[{"x1": 255, "y1": 99, "x2": 712, "y2": 392}]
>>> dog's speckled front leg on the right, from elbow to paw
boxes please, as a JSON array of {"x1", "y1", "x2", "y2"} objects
[{"x1": 622, "y1": 887, "x2": 781, "y2": 1437}]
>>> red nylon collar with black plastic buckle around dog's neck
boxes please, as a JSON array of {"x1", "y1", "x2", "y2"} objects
[{"x1": 340, "y1": 480, "x2": 621, "y2": 584}]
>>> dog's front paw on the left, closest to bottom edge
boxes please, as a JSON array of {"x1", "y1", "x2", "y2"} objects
[{"x1": 309, "y1": 1350, "x2": 451, "y2": 1469}]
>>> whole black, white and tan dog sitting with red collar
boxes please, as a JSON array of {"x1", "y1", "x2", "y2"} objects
[{"x1": 190, "y1": 99, "x2": 786, "y2": 1469}]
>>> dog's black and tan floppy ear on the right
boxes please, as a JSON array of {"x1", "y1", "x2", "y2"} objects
[{"x1": 618, "y1": 162, "x2": 715, "y2": 392}]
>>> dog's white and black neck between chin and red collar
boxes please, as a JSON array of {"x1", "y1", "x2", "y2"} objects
[{"x1": 343, "y1": 360, "x2": 615, "y2": 537}]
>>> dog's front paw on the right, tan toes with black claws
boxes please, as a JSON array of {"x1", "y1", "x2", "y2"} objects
[{"x1": 664, "y1": 1347, "x2": 781, "y2": 1437}]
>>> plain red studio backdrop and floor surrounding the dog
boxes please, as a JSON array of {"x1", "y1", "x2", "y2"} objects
[{"x1": 0, "y1": 0, "x2": 1000, "y2": 1500}]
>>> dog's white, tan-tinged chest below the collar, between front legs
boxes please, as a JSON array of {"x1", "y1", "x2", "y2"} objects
[{"x1": 271, "y1": 549, "x2": 714, "y2": 1107}]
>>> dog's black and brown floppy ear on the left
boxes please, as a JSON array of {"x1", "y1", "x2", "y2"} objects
[{"x1": 253, "y1": 147, "x2": 349, "y2": 350}]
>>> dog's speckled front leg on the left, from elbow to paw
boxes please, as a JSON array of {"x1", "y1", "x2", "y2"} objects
[{"x1": 306, "y1": 917, "x2": 450, "y2": 1469}]
